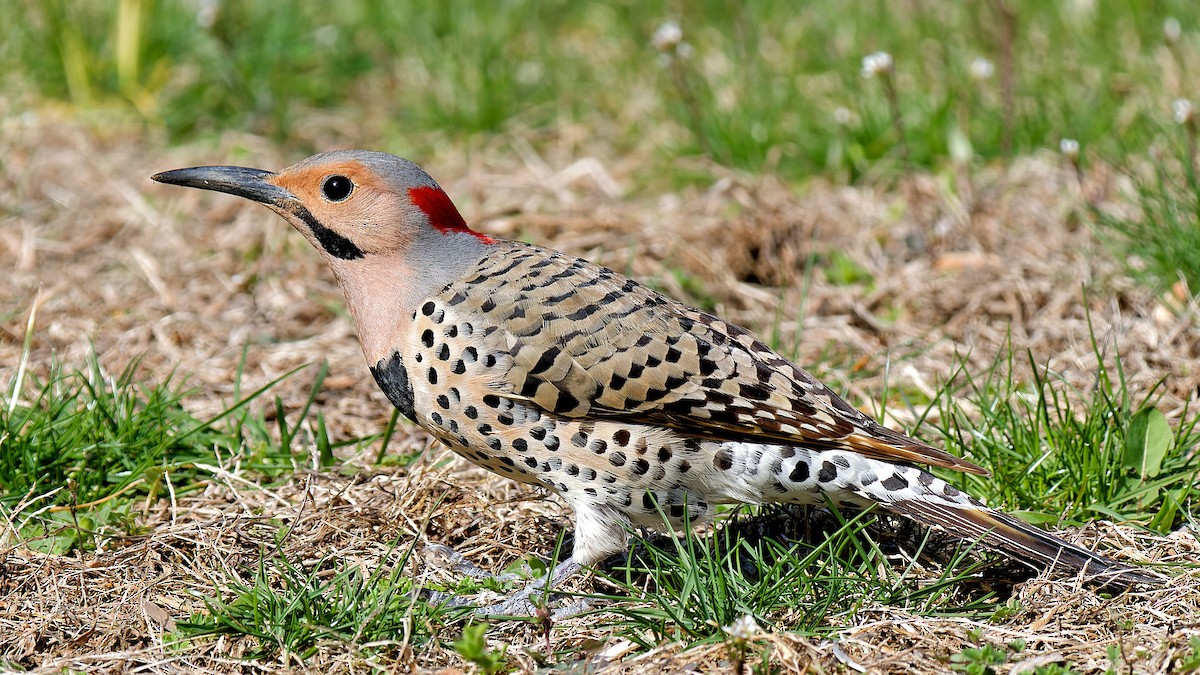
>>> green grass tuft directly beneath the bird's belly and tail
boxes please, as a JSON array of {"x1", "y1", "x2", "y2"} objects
[{"x1": 599, "y1": 507, "x2": 1000, "y2": 649}]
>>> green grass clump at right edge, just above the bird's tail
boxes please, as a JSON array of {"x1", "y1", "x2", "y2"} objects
[{"x1": 930, "y1": 324, "x2": 1200, "y2": 532}]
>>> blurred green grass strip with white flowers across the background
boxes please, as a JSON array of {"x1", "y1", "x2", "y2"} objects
[{"x1": 0, "y1": 0, "x2": 1200, "y2": 177}]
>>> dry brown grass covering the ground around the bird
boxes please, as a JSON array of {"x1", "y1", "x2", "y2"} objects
[{"x1": 0, "y1": 117, "x2": 1200, "y2": 673}]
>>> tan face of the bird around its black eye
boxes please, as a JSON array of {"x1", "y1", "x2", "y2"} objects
[{"x1": 266, "y1": 160, "x2": 424, "y2": 258}]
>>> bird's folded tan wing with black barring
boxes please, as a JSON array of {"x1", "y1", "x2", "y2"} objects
[{"x1": 443, "y1": 243, "x2": 986, "y2": 474}]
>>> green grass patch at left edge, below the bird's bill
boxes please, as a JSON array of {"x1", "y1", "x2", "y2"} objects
[{"x1": 0, "y1": 345, "x2": 364, "y2": 552}]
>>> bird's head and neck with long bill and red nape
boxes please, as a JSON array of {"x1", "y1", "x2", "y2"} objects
[{"x1": 152, "y1": 150, "x2": 494, "y2": 363}]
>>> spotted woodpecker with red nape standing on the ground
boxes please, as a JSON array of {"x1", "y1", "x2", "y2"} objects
[{"x1": 152, "y1": 150, "x2": 1157, "y2": 609}]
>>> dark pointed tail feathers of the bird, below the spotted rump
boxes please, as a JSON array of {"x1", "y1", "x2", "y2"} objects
[{"x1": 884, "y1": 500, "x2": 1163, "y2": 589}]
